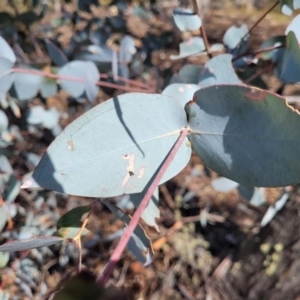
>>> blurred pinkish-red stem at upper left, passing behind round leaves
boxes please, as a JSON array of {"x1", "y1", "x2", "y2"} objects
[{"x1": 10, "y1": 68, "x2": 154, "y2": 93}]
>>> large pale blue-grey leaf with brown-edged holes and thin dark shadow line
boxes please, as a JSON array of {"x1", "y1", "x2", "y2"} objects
[{"x1": 23, "y1": 93, "x2": 191, "y2": 197}]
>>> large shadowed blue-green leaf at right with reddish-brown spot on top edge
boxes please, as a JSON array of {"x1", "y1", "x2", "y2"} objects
[{"x1": 186, "y1": 85, "x2": 300, "y2": 187}]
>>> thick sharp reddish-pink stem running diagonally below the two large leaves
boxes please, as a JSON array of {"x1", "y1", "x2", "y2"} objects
[{"x1": 97, "y1": 128, "x2": 188, "y2": 286}]
